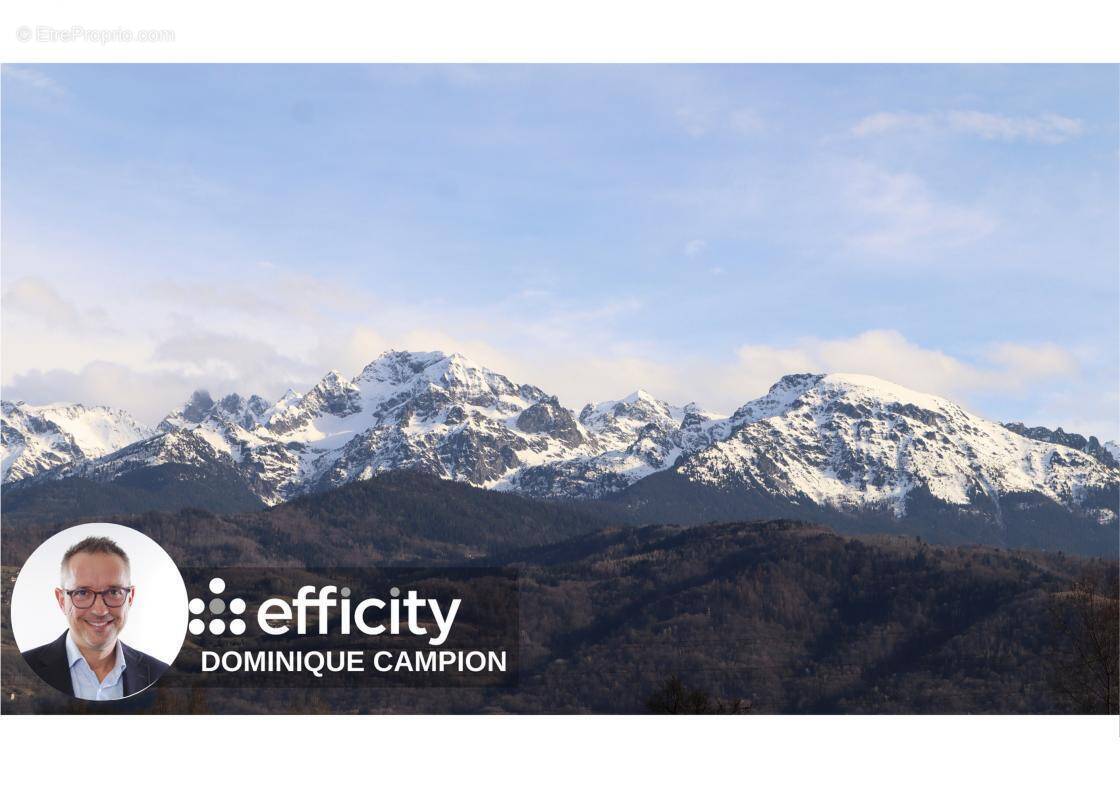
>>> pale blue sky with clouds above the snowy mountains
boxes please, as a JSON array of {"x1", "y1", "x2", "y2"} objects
[{"x1": 2, "y1": 65, "x2": 1120, "y2": 438}]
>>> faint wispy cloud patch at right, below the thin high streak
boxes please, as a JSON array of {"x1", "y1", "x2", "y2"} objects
[{"x1": 840, "y1": 162, "x2": 998, "y2": 260}]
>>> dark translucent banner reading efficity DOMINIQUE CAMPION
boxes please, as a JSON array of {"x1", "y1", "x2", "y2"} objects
[{"x1": 160, "y1": 567, "x2": 519, "y2": 688}]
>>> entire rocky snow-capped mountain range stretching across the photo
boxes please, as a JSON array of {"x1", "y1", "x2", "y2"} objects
[{"x1": 2, "y1": 351, "x2": 1120, "y2": 523}]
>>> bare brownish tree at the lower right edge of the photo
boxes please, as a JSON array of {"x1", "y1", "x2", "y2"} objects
[{"x1": 1051, "y1": 564, "x2": 1120, "y2": 714}]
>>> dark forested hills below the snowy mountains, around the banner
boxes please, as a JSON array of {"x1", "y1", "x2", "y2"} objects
[{"x1": 3, "y1": 474, "x2": 1120, "y2": 714}]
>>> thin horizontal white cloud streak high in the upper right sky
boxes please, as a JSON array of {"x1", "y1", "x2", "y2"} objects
[{"x1": 851, "y1": 110, "x2": 1084, "y2": 145}]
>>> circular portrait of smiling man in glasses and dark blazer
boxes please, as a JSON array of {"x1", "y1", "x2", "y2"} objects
[{"x1": 11, "y1": 522, "x2": 188, "y2": 700}]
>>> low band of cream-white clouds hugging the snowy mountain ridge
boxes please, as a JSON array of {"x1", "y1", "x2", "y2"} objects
[{"x1": 3, "y1": 325, "x2": 1097, "y2": 435}]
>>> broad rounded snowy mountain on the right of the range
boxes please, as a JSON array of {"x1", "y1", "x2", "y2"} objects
[{"x1": 682, "y1": 373, "x2": 1118, "y2": 515}]
